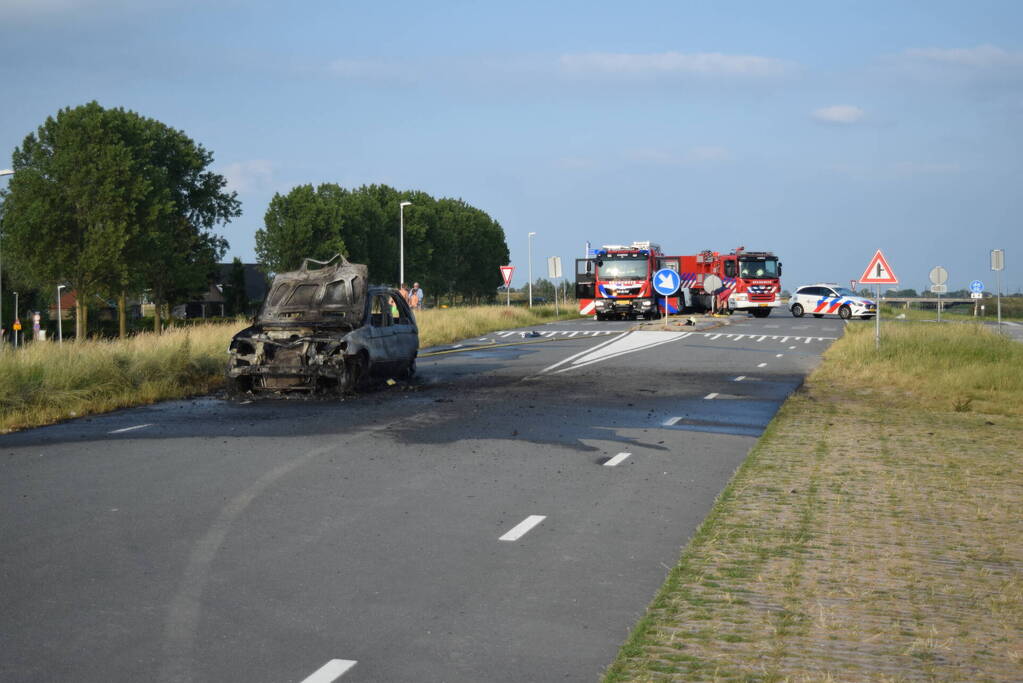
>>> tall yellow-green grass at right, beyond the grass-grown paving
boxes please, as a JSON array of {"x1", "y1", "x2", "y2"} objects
[{"x1": 819, "y1": 323, "x2": 1023, "y2": 415}]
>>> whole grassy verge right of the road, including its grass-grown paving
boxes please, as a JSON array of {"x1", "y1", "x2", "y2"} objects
[{"x1": 605, "y1": 323, "x2": 1023, "y2": 682}]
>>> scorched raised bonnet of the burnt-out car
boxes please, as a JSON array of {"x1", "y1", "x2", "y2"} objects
[{"x1": 256, "y1": 254, "x2": 368, "y2": 326}]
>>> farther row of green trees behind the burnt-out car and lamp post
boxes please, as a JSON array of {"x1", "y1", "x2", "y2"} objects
[{"x1": 256, "y1": 183, "x2": 508, "y2": 301}]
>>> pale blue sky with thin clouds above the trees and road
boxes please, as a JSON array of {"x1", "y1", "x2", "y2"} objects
[{"x1": 0, "y1": 0, "x2": 1023, "y2": 291}]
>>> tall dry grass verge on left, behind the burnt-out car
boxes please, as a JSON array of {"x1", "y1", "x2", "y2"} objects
[{"x1": 0, "y1": 306, "x2": 576, "y2": 432}]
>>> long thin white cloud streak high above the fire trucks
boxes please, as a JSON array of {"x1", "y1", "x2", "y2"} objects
[{"x1": 560, "y1": 52, "x2": 792, "y2": 79}]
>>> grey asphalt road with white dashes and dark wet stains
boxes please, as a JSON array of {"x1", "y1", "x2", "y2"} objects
[{"x1": 0, "y1": 314, "x2": 847, "y2": 683}]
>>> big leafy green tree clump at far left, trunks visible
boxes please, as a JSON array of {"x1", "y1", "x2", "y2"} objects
[{"x1": 0, "y1": 102, "x2": 241, "y2": 338}]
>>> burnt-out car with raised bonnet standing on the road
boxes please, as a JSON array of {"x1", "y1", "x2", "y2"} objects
[{"x1": 227, "y1": 255, "x2": 419, "y2": 394}]
